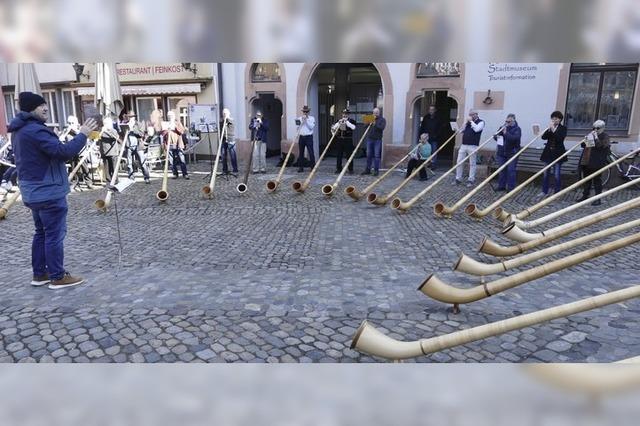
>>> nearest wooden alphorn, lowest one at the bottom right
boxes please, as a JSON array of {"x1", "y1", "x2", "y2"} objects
[{"x1": 351, "y1": 285, "x2": 640, "y2": 360}]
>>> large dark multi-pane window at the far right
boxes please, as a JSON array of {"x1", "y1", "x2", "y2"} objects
[{"x1": 565, "y1": 64, "x2": 638, "y2": 135}]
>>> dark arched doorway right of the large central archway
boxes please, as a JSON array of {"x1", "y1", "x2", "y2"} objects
[{"x1": 411, "y1": 90, "x2": 458, "y2": 164}]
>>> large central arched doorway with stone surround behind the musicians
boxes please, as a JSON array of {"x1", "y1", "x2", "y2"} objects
[{"x1": 296, "y1": 63, "x2": 393, "y2": 165}]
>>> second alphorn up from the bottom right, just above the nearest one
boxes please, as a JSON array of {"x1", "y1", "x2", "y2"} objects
[{"x1": 418, "y1": 232, "x2": 640, "y2": 311}]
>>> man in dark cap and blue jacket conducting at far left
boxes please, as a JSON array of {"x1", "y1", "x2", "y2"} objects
[{"x1": 9, "y1": 92, "x2": 97, "y2": 289}]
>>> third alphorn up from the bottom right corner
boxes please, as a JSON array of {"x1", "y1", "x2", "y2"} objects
[{"x1": 453, "y1": 219, "x2": 640, "y2": 276}]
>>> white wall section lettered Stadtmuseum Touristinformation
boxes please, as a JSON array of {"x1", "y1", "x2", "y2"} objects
[{"x1": 461, "y1": 62, "x2": 562, "y2": 149}]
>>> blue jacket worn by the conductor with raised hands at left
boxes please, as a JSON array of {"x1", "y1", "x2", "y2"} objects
[{"x1": 8, "y1": 112, "x2": 87, "y2": 203}]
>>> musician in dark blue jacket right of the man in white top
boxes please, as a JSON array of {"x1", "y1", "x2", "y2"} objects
[{"x1": 493, "y1": 114, "x2": 522, "y2": 191}]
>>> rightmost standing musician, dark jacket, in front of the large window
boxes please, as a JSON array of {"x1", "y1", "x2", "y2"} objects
[{"x1": 578, "y1": 120, "x2": 610, "y2": 206}]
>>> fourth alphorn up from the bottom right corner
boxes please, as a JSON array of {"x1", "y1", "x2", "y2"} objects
[{"x1": 478, "y1": 198, "x2": 640, "y2": 257}]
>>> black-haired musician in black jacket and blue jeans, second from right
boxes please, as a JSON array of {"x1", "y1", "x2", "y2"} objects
[{"x1": 539, "y1": 111, "x2": 567, "y2": 197}]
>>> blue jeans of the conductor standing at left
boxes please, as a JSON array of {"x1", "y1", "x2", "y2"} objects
[{"x1": 24, "y1": 197, "x2": 68, "y2": 280}]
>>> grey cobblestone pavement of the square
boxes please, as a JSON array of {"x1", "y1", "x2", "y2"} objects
[{"x1": 0, "y1": 159, "x2": 640, "y2": 362}]
